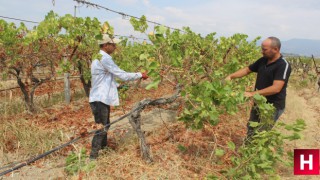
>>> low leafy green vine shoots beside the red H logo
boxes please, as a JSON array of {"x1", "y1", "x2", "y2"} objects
[{"x1": 222, "y1": 95, "x2": 306, "y2": 179}]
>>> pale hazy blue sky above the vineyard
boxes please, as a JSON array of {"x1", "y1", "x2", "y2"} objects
[{"x1": 0, "y1": 0, "x2": 320, "y2": 40}]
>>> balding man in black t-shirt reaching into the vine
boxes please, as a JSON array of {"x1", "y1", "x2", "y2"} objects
[{"x1": 226, "y1": 37, "x2": 291, "y2": 137}]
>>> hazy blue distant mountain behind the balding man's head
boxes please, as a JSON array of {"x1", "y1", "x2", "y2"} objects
[{"x1": 281, "y1": 39, "x2": 320, "y2": 57}]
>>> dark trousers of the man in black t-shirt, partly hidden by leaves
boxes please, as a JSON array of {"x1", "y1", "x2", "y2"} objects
[{"x1": 247, "y1": 106, "x2": 284, "y2": 139}]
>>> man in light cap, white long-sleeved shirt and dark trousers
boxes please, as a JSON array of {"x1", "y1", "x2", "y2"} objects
[{"x1": 89, "y1": 34, "x2": 148, "y2": 159}]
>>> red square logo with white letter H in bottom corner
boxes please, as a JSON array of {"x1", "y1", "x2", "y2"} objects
[{"x1": 294, "y1": 149, "x2": 320, "y2": 175}]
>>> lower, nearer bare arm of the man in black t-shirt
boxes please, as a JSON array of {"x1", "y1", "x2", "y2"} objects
[{"x1": 244, "y1": 80, "x2": 285, "y2": 97}]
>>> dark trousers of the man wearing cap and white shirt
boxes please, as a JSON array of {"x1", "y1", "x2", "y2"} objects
[{"x1": 90, "y1": 102, "x2": 110, "y2": 157}]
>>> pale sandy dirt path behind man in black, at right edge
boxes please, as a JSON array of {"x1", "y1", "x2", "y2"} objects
[{"x1": 280, "y1": 88, "x2": 320, "y2": 180}]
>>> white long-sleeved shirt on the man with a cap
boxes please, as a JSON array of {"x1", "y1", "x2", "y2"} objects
[{"x1": 89, "y1": 50, "x2": 142, "y2": 106}]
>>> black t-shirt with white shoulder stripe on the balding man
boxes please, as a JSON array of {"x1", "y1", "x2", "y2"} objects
[{"x1": 249, "y1": 56, "x2": 291, "y2": 109}]
